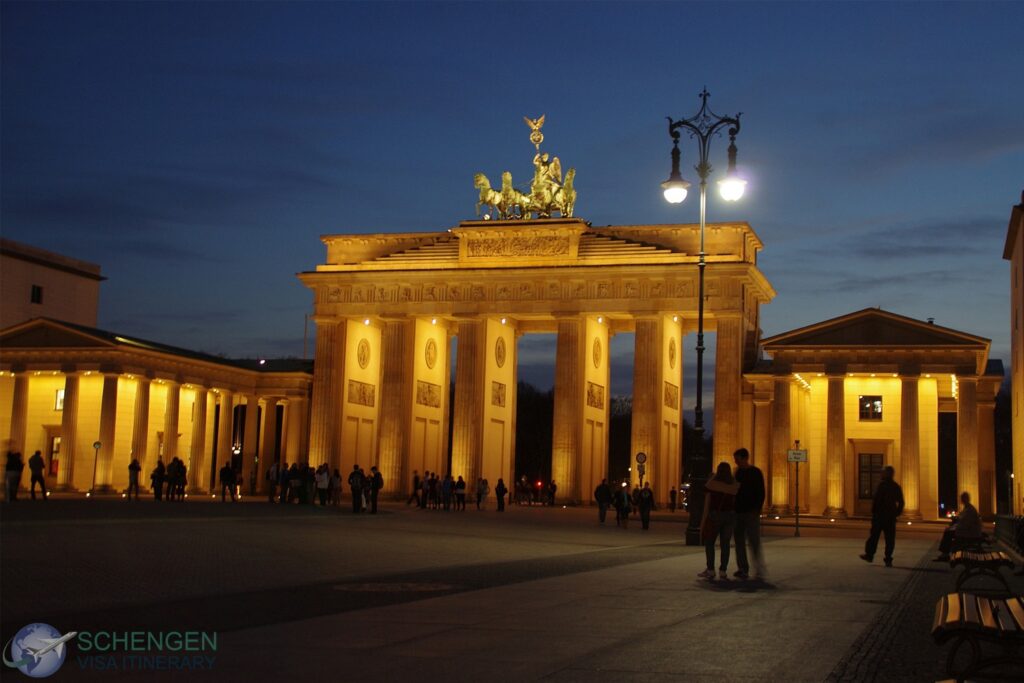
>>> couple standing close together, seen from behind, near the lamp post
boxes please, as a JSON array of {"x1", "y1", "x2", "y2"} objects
[{"x1": 697, "y1": 449, "x2": 766, "y2": 580}]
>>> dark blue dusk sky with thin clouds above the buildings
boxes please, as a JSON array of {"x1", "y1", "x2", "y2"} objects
[{"x1": 0, "y1": 2, "x2": 1024, "y2": 401}]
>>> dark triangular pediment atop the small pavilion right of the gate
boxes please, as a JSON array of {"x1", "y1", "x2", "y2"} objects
[{"x1": 763, "y1": 308, "x2": 989, "y2": 351}]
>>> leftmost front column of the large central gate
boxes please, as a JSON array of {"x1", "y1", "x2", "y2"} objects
[{"x1": 307, "y1": 317, "x2": 346, "y2": 469}]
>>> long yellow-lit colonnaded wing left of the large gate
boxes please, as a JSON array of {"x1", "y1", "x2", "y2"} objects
[{"x1": 0, "y1": 318, "x2": 312, "y2": 492}]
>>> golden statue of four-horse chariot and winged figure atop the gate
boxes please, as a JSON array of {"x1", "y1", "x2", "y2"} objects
[{"x1": 473, "y1": 115, "x2": 575, "y2": 220}]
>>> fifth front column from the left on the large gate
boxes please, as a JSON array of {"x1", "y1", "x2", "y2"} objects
[{"x1": 626, "y1": 318, "x2": 664, "y2": 486}]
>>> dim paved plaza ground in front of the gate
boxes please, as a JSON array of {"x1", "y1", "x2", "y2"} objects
[{"x1": 0, "y1": 499, "x2": 1024, "y2": 681}]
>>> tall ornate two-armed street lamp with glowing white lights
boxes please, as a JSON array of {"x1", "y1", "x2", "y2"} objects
[{"x1": 662, "y1": 88, "x2": 746, "y2": 546}]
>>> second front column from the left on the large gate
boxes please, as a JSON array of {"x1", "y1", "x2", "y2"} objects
[{"x1": 378, "y1": 321, "x2": 413, "y2": 496}]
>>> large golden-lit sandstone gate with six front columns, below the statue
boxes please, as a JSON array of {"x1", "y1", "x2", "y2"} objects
[{"x1": 299, "y1": 219, "x2": 775, "y2": 502}]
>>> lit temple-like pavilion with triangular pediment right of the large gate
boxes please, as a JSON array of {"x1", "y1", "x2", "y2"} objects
[{"x1": 744, "y1": 308, "x2": 1002, "y2": 519}]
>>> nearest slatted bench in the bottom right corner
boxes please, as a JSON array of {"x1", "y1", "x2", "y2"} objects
[{"x1": 932, "y1": 593, "x2": 1024, "y2": 681}]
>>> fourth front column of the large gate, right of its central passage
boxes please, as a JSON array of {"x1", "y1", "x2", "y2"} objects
[{"x1": 551, "y1": 317, "x2": 590, "y2": 501}]
